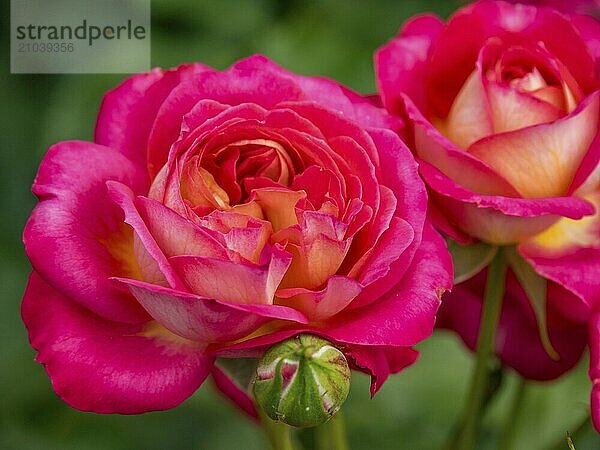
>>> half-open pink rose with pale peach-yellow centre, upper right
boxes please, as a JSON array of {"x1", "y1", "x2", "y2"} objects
[{"x1": 376, "y1": 2, "x2": 600, "y2": 244}]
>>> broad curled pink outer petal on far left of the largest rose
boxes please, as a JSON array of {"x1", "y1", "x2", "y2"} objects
[{"x1": 23, "y1": 141, "x2": 147, "y2": 322}]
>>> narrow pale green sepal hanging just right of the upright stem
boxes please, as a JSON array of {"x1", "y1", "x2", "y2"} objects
[{"x1": 504, "y1": 247, "x2": 560, "y2": 361}]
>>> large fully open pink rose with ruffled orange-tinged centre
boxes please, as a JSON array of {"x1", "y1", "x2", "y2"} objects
[{"x1": 22, "y1": 56, "x2": 451, "y2": 414}]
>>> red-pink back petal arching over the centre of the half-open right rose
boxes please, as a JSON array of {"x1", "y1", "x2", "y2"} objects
[{"x1": 428, "y1": 2, "x2": 598, "y2": 117}]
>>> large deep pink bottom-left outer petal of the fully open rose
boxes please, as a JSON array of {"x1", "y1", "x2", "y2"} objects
[{"x1": 22, "y1": 273, "x2": 212, "y2": 414}]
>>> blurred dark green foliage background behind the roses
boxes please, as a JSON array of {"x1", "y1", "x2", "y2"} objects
[{"x1": 0, "y1": 0, "x2": 600, "y2": 450}]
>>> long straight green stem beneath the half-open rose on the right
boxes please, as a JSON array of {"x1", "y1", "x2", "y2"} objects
[{"x1": 458, "y1": 251, "x2": 506, "y2": 450}]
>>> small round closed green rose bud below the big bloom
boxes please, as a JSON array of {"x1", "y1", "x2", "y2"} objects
[{"x1": 254, "y1": 334, "x2": 350, "y2": 427}]
